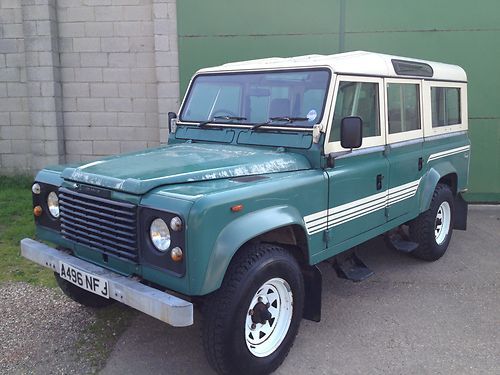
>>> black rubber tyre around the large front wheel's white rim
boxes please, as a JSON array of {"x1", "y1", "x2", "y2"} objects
[{"x1": 203, "y1": 244, "x2": 304, "y2": 374}]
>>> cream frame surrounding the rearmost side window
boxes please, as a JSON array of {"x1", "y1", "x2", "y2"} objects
[{"x1": 423, "y1": 81, "x2": 468, "y2": 137}]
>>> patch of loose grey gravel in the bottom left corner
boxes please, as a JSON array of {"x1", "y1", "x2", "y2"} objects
[{"x1": 0, "y1": 283, "x2": 97, "y2": 374}]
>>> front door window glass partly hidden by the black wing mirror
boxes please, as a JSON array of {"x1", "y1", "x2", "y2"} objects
[{"x1": 329, "y1": 81, "x2": 380, "y2": 142}]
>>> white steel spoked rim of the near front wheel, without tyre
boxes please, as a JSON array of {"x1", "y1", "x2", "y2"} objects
[{"x1": 245, "y1": 278, "x2": 293, "y2": 357}]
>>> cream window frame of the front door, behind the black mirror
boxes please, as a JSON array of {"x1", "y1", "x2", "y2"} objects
[{"x1": 324, "y1": 75, "x2": 386, "y2": 155}]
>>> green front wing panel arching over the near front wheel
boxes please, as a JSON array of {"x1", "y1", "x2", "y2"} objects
[{"x1": 180, "y1": 170, "x2": 327, "y2": 294}]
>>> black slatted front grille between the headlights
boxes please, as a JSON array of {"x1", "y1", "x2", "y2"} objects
[{"x1": 59, "y1": 188, "x2": 137, "y2": 260}]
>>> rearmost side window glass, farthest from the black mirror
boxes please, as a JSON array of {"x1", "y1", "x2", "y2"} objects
[{"x1": 431, "y1": 87, "x2": 462, "y2": 128}]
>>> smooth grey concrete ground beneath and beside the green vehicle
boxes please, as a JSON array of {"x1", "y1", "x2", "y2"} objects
[{"x1": 102, "y1": 206, "x2": 500, "y2": 375}]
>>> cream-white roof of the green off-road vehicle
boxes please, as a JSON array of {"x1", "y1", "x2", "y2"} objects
[{"x1": 198, "y1": 51, "x2": 467, "y2": 82}]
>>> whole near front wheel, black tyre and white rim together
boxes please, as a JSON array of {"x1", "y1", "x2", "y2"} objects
[{"x1": 203, "y1": 244, "x2": 304, "y2": 374}]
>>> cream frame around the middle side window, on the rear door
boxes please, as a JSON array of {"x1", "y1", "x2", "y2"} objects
[{"x1": 384, "y1": 78, "x2": 424, "y2": 144}]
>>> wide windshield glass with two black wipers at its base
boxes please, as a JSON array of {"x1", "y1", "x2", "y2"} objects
[{"x1": 180, "y1": 69, "x2": 330, "y2": 127}]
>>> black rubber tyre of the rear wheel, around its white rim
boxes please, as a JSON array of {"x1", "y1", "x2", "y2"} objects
[{"x1": 410, "y1": 184, "x2": 454, "y2": 262}]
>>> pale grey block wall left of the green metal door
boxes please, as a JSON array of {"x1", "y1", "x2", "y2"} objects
[{"x1": 0, "y1": 0, "x2": 179, "y2": 173}]
